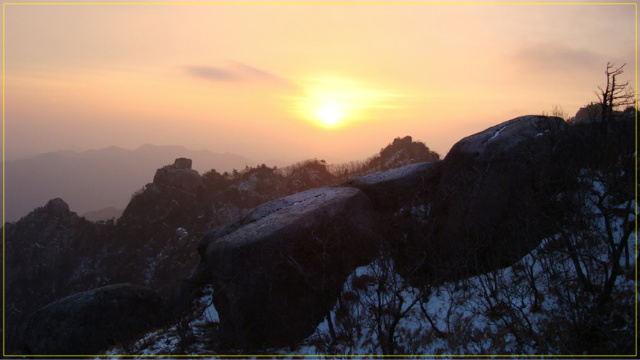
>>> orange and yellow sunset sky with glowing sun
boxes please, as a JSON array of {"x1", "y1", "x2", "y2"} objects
[{"x1": 4, "y1": 2, "x2": 637, "y2": 163}]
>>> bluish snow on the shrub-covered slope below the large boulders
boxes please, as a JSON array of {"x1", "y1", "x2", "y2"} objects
[{"x1": 288, "y1": 172, "x2": 638, "y2": 356}]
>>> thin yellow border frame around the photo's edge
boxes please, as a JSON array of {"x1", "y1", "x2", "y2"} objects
[{"x1": 2, "y1": 2, "x2": 638, "y2": 358}]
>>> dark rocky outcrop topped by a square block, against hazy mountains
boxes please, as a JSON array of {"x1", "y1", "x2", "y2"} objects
[{"x1": 114, "y1": 158, "x2": 211, "y2": 301}]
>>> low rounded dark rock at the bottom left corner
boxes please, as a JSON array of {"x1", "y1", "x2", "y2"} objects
[{"x1": 22, "y1": 284, "x2": 170, "y2": 355}]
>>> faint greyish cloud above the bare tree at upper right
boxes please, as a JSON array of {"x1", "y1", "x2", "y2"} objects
[{"x1": 514, "y1": 41, "x2": 607, "y2": 72}]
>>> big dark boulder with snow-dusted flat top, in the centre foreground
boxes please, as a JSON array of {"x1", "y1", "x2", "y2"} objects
[{"x1": 199, "y1": 187, "x2": 378, "y2": 350}]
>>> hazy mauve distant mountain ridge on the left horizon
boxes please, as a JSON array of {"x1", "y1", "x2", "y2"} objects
[{"x1": 4, "y1": 144, "x2": 257, "y2": 221}]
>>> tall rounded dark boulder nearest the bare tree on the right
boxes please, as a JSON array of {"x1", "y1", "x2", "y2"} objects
[{"x1": 399, "y1": 116, "x2": 566, "y2": 283}]
